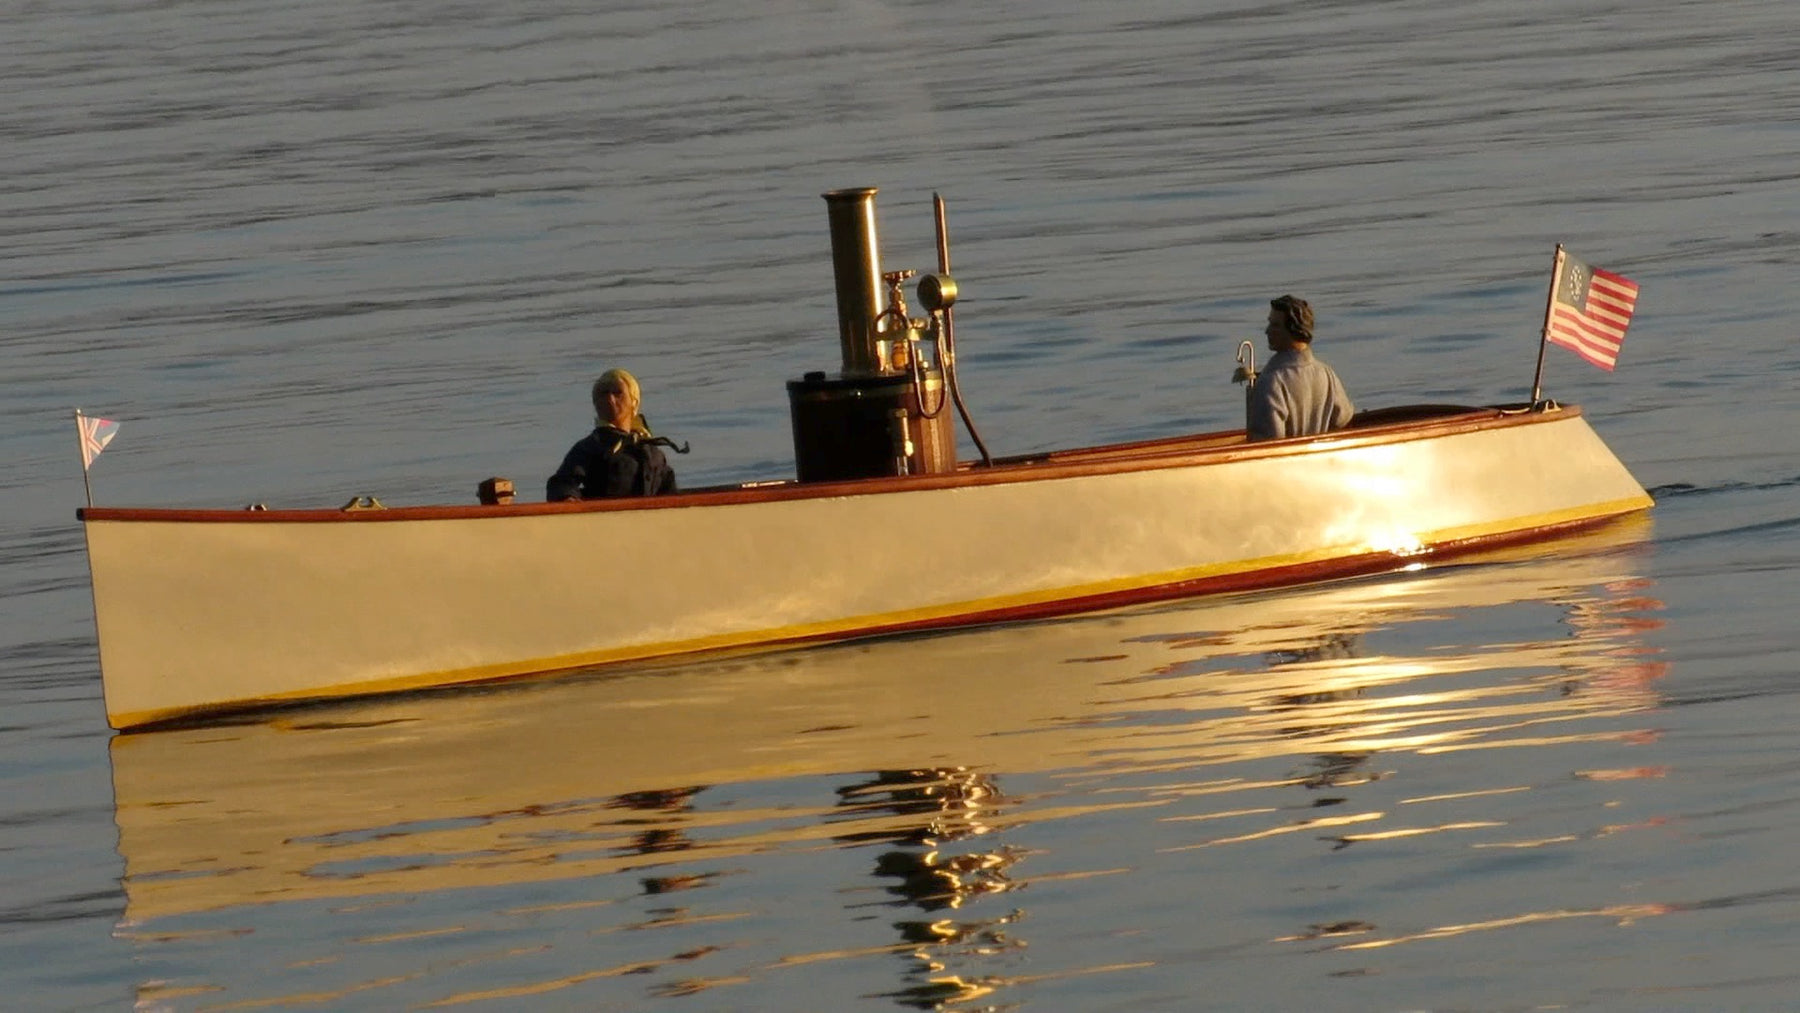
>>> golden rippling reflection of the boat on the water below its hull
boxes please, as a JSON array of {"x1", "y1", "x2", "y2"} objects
[{"x1": 112, "y1": 522, "x2": 1660, "y2": 1008}]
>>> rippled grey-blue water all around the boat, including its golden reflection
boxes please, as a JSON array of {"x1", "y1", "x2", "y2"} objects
[{"x1": 0, "y1": 0, "x2": 1800, "y2": 1009}]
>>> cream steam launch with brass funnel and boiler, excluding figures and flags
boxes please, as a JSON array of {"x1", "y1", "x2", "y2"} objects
[{"x1": 79, "y1": 189, "x2": 1651, "y2": 729}]
